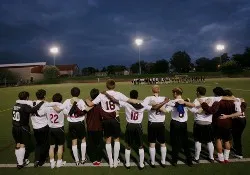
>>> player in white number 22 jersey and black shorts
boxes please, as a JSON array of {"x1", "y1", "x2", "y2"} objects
[{"x1": 38, "y1": 93, "x2": 68, "y2": 169}]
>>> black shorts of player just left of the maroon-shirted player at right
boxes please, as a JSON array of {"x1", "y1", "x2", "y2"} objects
[{"x1": 193, "y1": 123, "x2": 214, "y2": 143}]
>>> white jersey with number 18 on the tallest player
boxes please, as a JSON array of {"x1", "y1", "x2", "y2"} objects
[{"x1": 92, "y1": 90, "x2": 129, "y2": 112}]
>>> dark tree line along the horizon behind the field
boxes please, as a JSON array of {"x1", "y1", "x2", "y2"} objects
[{"x1": 82, "y1": 47, "x2": 250, "y2": 75}]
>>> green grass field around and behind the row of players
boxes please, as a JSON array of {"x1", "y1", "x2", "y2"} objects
[{"x1": 0, "y1": 78, "x2": 250, "y2": 175}]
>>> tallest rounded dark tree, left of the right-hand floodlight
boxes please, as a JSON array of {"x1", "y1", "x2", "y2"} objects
[{"x1": 170, "y1": 51, "x2": 191, "y2": 72}]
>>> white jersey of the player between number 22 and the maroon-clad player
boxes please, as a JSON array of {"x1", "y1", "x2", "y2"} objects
[{"x1": 61, "y1": 98, "x2": 86, "y2": 122}]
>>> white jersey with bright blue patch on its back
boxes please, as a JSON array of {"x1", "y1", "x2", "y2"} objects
[{"x1": 166, "y1": 99, "x2": 188, "y2": 122}]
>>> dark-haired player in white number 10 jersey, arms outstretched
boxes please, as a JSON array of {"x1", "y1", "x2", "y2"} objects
[{"x1": 106, "y1": 90, "x2": 169, "y2": 169}]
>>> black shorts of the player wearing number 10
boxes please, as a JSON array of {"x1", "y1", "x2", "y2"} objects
[{"x1": 125, "y1": 123, "x2": 143, "y2": 146}]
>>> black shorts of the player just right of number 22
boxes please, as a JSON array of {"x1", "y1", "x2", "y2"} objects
[{"x1": 69, "y1": 121, "x2": 86, "y2": 140}]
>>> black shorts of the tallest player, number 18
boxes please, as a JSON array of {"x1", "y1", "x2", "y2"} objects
[{"x1": 103, "y1": 117, "x2": 121, "y2": 139}]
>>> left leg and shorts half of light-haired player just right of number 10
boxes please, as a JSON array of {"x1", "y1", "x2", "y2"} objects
[{"x1": 148, "y1": 122, "x2": 156, "y2": 168}]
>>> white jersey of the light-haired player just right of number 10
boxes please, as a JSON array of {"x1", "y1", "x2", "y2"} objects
[{"x1": 142, "y1": 96, "x2": 165, "y2": 122}]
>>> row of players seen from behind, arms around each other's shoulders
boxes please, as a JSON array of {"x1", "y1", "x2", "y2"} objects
[{"x1": 12, "y1": 79, "x2": 247, "y2": 169}]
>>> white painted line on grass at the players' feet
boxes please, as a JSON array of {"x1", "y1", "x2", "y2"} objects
[{"x1": 0, "y1": 158, "x2": 250, "y2": 168}]
